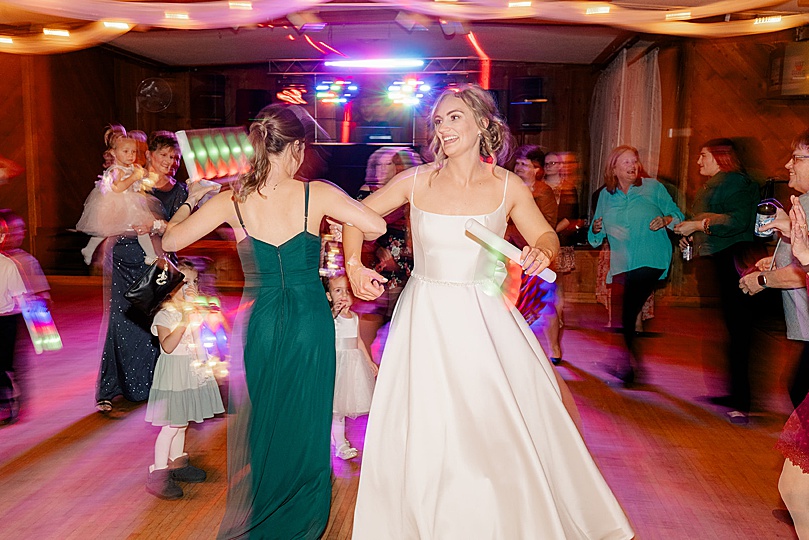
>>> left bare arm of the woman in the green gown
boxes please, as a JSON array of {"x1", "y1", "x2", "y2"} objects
[{"x1": 163, "y1": 191, "x2": 238, "y2": 252}]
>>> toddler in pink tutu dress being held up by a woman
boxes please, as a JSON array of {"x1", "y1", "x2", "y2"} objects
[{"x1": 76, "y1": 126, "x2": 163, "y2": 264}]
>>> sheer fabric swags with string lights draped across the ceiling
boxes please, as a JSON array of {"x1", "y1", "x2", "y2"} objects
[{"x1": 0, "y1": 0, "x2": 809, "y2": 54}]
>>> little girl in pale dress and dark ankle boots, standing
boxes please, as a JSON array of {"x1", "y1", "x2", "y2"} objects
[{"x1": 146, "y1": 259, "x2": 225, "y2": 500}]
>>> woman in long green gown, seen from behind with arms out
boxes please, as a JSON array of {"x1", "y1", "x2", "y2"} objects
[{"x1": 163, "y1": 105, "x2": 385, "y2": 540}]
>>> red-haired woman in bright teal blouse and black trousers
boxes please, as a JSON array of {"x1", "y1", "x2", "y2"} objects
[{"x1": 587, "y1": 146, "x2": 683, "y2": 385}]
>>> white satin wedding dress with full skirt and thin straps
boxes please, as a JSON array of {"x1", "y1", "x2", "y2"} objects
[{"x1": 353, "y1": 172, "x2": 633, "y2": 540}]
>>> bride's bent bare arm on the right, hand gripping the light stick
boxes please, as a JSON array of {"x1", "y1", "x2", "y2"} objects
[{"x1": 506, "y1": 175, "x2": 559, "y2": 276}]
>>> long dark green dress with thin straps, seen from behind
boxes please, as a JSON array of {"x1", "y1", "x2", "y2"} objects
[{"x1": 219, "y1": 184, "x2": 335, "y2": 540}]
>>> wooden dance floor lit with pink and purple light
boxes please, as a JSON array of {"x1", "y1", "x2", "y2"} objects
[{"x1": 0, "y1": 286, "x2": 795, "y2": 540}]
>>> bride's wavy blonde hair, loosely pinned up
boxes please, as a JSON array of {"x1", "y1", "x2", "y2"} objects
[{"x1": 428, "y1": 84, "x2": 511, "y2": 164}]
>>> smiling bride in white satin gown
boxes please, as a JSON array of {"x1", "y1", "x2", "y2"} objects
[{"x1": 343, "y1": 86, "x2": 633, "y2": 540}]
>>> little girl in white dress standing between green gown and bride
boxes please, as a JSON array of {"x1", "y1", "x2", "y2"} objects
[{"x1": 326, "y1": 273, "x2": 379, "y2": 459}]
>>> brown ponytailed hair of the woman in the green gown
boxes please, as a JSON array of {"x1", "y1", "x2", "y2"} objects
[{"x1": 236, "y1": 104, "x2": 314, "y2": 202}]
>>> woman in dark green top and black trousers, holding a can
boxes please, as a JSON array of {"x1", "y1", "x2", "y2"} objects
[{"x1": 674, "y1": 139, "x2": 761, "y2": 424}]
